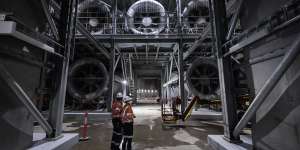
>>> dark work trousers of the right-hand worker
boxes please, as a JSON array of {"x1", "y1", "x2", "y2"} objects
[{"x1": 122, "y1": 122, "x2": 133, "y2": 150}]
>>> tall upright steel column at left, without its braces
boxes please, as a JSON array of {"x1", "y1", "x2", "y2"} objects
[{"x1": 47, "y1": 0, "x2": 77, "y2": 138}]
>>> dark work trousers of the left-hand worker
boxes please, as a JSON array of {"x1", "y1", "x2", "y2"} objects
[{"x1": 111, "y1": 118, "x2": 122, "y2": 150}]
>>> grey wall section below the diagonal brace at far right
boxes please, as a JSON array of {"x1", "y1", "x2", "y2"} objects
[{"x1": 253, "y1": 55, "x2": 300, "y2": 150}]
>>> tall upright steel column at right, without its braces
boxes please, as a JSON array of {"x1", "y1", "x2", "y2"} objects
[{"x1": 209, "y1": 0, "x2": 239, "y2": 142}]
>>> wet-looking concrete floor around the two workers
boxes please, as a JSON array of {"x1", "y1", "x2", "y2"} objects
[{"x1": 64, "y1": 104, "x2": 223, "y2": 150}]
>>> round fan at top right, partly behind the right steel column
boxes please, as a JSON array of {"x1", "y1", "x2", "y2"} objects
[{"x1": 182, "y1": 0, "x2": 209, "y2": 28}]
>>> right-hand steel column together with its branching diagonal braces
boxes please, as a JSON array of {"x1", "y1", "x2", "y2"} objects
[{"x1": 210, "y1": 0, "x2": 300, "y2": 142}]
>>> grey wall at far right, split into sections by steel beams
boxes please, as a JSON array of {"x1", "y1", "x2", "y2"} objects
[{"x1": 248, "y1": 12, "x2": 300, "y2": 150}]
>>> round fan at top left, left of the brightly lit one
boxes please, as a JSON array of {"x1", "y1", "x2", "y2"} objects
[{"x1": 78, "y1": 0, "x2": 110, "y2": 34}]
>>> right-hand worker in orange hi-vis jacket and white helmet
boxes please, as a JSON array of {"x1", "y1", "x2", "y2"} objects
[{"x1": 121, "y1": 97, "x2": 135, "y2": 150}]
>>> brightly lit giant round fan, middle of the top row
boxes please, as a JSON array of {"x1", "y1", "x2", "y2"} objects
[{"x1": 127, "y1": 0, "x2": 167, "y2": 35}]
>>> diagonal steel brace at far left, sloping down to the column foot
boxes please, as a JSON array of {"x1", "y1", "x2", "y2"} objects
[{"x1": 0, "y1": 64, "x2": 53, "y2": 135}]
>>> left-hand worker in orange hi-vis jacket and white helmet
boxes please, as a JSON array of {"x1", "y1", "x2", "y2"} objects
[{"x1": 111, "y1": 93, "x2": 123, "y2": 150}]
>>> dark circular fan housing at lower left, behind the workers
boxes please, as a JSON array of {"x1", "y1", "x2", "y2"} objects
[{"x1": 68, "y1": 58, "x2": 109, "y2": 102}]
